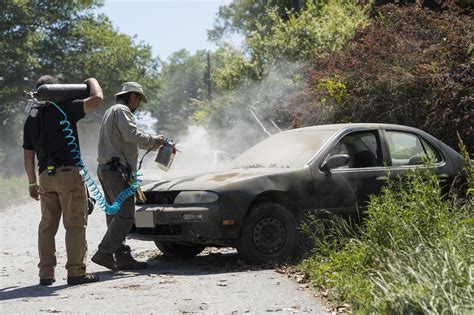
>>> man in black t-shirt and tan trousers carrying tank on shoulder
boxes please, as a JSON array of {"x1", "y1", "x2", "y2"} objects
[{"x1": 23, "y1": 76, "x2": 103, "y2": 285}]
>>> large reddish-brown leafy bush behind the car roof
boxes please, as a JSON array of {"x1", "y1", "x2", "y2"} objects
[{"x1": 289, "y1": 5, "x2": 474, "y2": 152}]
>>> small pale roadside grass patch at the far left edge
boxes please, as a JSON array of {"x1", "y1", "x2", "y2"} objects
[{"x1": 0, "y1": 174, "x2": 29, "y2": 209}]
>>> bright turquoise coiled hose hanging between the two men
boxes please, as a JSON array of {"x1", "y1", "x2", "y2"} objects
[{"x1": 47, "y1": 101, "x2": 145, "y2": 214}]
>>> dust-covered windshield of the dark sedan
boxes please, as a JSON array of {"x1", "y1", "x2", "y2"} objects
[{"x1": 231, "y1": 130, "x2": 336, "y2": 168}]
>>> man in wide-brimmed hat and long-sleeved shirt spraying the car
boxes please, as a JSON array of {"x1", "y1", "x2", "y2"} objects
[{"x1": 92, "y1": 82, "x2": 164, "y2": 270}]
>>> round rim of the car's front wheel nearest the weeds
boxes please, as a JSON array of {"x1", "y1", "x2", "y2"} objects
[{"x1": 253, "y1": 217, "x2": 286, "y2": 255}]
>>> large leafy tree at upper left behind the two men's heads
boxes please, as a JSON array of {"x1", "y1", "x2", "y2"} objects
[{"x1": 0, "y1": 0, "x2": 157, "y2": 171}]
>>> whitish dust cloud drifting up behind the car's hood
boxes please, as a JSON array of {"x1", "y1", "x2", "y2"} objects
[{"x1": 139, "y1": 62, "x2": 302, "y2": 180}]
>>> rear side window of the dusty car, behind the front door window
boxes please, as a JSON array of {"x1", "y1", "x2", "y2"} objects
[{"x1": 386, "y1": 131, "x2": 442, "y2": 166}]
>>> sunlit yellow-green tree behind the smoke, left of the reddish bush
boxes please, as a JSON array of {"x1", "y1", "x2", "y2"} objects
[{"x1": 192, "y1": 0, "x2": 368, "y2": 138}]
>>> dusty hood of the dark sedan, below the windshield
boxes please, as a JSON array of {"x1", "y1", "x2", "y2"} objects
[{"x1": 143, "y1": 168, "x2": 292, "y2": 191}]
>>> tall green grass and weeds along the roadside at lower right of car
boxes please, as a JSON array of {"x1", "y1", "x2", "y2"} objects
[{"x1": 299, "y1": 172, "x2": 474, "y2": 314}]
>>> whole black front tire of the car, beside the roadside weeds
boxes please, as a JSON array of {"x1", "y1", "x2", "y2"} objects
[{"x1": 236, "y1": 202, "x2": 298, "y2": 263}]
